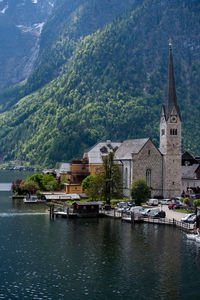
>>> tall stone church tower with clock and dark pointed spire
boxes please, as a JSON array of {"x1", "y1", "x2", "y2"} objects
[{"x1": 160, "y1": 42, "x2": 182, "y2": 198}]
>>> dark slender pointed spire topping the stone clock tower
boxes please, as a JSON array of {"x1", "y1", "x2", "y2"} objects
[{"x1": 164, "y1": 39, "x2": 181, "y2": 120}]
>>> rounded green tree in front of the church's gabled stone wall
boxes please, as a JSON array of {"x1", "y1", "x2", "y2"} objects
[{"x1": 131, "y1": 177, "x2": 151, "y2": 205}]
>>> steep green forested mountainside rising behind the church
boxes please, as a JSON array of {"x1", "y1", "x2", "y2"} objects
[{"x1": 0, "y1": 0, "x2": 200, "y2": 166}]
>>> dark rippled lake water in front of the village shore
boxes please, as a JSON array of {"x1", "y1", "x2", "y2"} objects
[{"x1": 0, "y1": 174, "x2": 200, "y2": 300}]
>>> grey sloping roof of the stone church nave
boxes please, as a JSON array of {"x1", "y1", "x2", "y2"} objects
[{"x1": 115, "y1": 138, "x2": 149, "y2": 159}]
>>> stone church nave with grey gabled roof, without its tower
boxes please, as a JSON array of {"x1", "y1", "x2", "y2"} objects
[{"x1": 115, "y1": 138, "x2": 163, "y2": 197}]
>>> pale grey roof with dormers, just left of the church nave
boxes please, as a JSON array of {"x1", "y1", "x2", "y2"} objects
[{"x1": 88, "y1": 141, "x2": 121, "y2": 164}]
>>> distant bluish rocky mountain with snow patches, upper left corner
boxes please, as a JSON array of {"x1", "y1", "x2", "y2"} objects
[{"x1": 0, "y1": 0, "x2": 55, "y2": 88}]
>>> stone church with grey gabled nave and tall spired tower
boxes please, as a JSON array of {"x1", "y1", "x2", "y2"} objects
[{"x1": 115, "y1": 43, "x2": 182, "y2": 198}]
